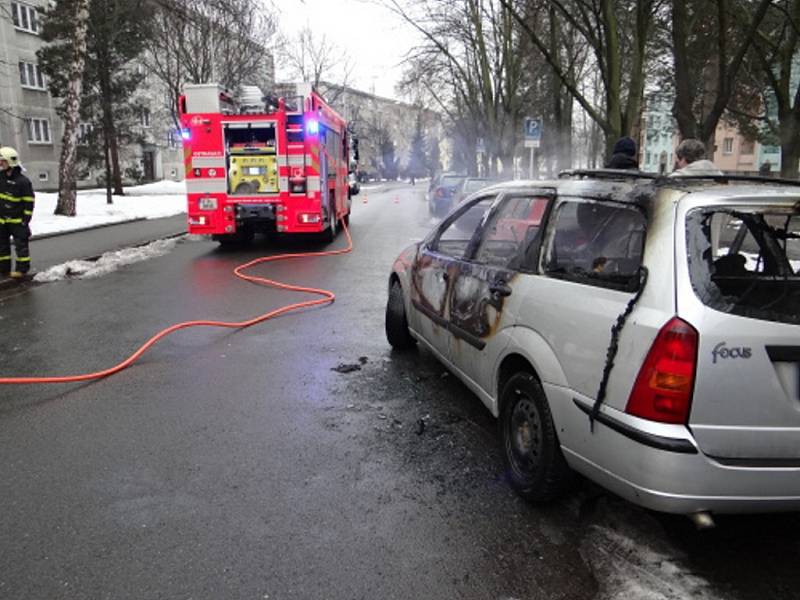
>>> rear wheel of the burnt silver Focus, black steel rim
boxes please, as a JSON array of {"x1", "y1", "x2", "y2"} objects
[{"x1": 498, "y1": 372, "x2": 572, "y2": 502}]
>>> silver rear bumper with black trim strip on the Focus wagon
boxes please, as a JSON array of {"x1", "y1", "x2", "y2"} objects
[{"x1": 548, "y1": 393, "x2": 800, "y2": 514}]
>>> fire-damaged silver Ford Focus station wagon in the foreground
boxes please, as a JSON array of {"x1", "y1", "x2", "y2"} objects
[{"x1": 386, "y1": 171, "x2": 800, "y2": 525}]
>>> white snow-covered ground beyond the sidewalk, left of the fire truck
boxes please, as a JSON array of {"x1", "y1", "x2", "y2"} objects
[{"x1": 31, "y1": 181, "x2": 186, "y2": 236}]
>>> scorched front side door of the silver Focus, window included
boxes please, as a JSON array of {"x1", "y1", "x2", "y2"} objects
[{"x1": 409, "y1": 194, "x2": 496, "y2": 360}]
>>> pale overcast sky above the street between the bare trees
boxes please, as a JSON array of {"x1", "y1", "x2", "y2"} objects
[{"x1": 277, "y1": 0, "x2": 416, "y2": 98}]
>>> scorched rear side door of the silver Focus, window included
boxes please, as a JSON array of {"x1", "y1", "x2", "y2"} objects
[{"x1": 449, "y1": 195, "x2": 552, "y2": 395}]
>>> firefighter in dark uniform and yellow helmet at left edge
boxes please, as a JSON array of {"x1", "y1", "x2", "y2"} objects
[{"x1": 0, "y1": 146, "x2": 33, "y2": 278}]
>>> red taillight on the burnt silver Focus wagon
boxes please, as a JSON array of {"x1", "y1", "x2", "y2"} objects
[{"x1": 625, "y1": 317, "x2": 697, "y2": 423}]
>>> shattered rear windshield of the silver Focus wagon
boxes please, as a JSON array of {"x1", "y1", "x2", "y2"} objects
[{"x1": 686, "y1": 204, "x2": 800, "y2": 324}]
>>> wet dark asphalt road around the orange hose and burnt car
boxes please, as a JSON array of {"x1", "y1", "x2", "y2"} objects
[{"x1": 0, "y1": 185, "x2": 800, "y2": 600}]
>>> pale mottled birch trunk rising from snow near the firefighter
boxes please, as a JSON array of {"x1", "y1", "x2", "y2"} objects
[{"x1": 55, "y1": 0, "x2": 89, "y2": 217}]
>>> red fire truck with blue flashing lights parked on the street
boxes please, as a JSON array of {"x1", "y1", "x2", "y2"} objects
[{"x1": 179, "y1": 84, "x2": 358, "y2": 244}]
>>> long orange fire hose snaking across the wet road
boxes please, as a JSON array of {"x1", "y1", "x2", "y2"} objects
[{"x1": 0, "y1": 221, "x2": 353, "y2": 385}]
